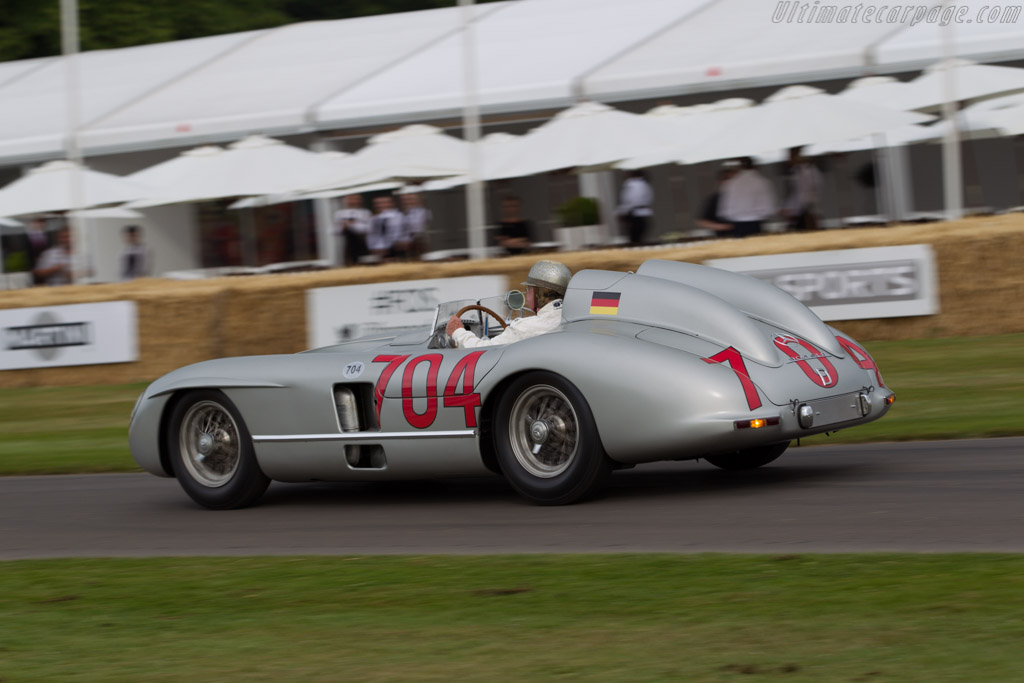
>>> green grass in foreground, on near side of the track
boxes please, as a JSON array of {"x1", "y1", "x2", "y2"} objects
[{"x1": 0, "y1": 554, "x2": 1024, "y2": 681}]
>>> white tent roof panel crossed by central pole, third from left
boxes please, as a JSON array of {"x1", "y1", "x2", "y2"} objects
[{"x1": 317, "y1": 0, "x2": 709, "y2": 124}]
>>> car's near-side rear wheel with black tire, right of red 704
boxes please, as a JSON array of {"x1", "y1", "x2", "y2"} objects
[{"x1": 494, "y1": 371, "x2": 613, "y2": 505}]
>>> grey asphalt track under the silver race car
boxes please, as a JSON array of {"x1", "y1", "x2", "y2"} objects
[{"x1": 0, "y1": 438, "x2": 1024, "y2": 559}]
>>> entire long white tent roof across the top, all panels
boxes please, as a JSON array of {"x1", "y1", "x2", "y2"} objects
[{"x1": 0, "y1": 0, "x2": 1024, "y2": 165}]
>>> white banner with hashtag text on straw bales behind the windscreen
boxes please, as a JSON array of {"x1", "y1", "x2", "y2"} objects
[{"x1": 306, "y1": 275, "x2": 508, "y2": 348}]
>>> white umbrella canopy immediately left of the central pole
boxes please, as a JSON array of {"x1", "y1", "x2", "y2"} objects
[{"x1": 304, "y1": 124, "x2": 469, "y2": 191}]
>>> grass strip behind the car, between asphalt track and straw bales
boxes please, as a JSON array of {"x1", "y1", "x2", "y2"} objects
[{"x1": 0, "y1": 335, "x2": 1024, "y2": 475}]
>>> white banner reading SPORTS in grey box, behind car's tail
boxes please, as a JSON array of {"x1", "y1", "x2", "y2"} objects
[{"x1": 706, "y1": 245, "x2": 939, "y2": 321}]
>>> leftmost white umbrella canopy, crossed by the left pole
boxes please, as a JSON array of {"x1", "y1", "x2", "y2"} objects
[{"x1": 0, "y1": 161, "x2": 153, "y2": 216}]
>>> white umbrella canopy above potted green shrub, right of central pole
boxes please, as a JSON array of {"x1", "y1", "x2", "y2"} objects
[{"x1": 485, "y1": 102, "x2": 680, "y2": 180}]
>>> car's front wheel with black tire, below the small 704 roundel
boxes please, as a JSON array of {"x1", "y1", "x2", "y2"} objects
[{"x1": 165, "y1": 389, "x2": 270, "y2": 510}]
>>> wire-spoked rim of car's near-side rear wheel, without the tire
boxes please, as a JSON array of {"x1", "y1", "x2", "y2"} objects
[{"x1": 509, "y1": 384, "x2": 580, "y2": 479}]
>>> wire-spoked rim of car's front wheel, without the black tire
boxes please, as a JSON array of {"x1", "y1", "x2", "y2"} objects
[{"x1": 178, "y1": 400, "x2": 241, "y2": 488}]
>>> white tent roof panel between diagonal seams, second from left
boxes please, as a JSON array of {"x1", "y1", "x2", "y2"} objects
[{"x1": 82, "y1": 4, "x2": 501, "y2": 153}]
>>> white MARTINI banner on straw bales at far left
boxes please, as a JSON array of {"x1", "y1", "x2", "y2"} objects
[{"x1": 0, "y1": 301, "x2": 138, "y2": 370}]
